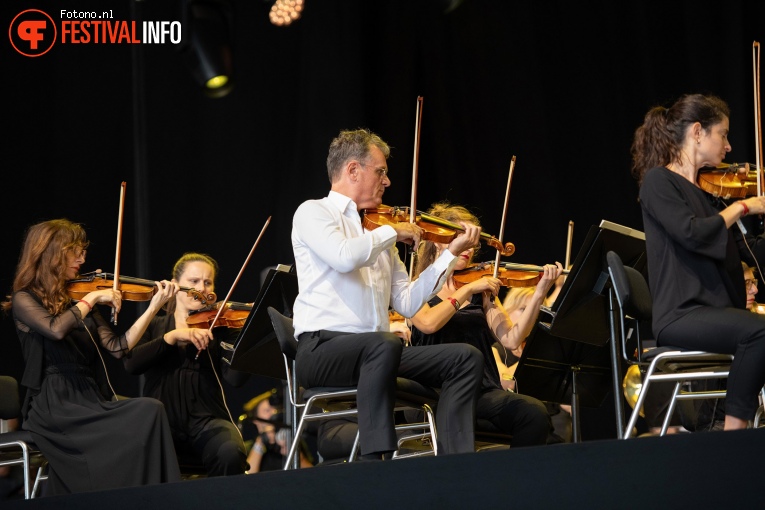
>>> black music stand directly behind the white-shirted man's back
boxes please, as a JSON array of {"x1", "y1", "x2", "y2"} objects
[{"x1": 223, "y1": 265, "x2": 298, "y2": 380}]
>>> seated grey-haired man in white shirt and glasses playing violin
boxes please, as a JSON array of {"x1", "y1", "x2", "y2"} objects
[{"x1": 292, "y1": 129, "x2": 483, "y2": 459}]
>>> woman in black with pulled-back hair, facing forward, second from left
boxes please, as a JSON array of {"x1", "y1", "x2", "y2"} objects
[{"x1": 125, "y1": 253, "x2": 249, "y2": 476}]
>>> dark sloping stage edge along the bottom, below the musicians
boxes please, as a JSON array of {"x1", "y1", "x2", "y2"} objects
[{"x1": 5, "y1": 429, "x2": 765, "y2": 510}]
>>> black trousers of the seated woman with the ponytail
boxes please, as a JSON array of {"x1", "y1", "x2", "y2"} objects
[{"x1": 657, "y1": 307, "x2": 765, "y2": 420}]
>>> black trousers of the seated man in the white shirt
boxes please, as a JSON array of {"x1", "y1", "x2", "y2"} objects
[{"x1": 295, "y1": 331, "x2": 483, "y2": 455}]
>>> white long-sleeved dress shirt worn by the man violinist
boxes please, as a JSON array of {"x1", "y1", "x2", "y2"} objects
[{"x1": 292, "y1": 191, "x2": 457, "y2": 338}]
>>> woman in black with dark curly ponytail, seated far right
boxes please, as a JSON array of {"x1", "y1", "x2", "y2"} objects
[{"x1": 632, "y1": 94, "x2": 765, "y2": 430}]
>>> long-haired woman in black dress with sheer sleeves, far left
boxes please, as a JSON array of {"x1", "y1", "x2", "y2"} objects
[{"x1": 2, "y1": 219, "x2": 180, "y2": 494}]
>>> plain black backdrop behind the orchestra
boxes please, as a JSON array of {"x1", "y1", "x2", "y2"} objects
[{"x1": 0, "y1": 0, "x2": 765, "y2": 438}]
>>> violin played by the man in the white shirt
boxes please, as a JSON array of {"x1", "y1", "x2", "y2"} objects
[{"x1": 361, "y1": 205, "x2": 515, "y2": 257}]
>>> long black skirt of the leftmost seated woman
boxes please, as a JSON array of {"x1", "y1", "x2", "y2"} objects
[{"x1": 23, "y1": 374, "x2": 180, "y2": 495}]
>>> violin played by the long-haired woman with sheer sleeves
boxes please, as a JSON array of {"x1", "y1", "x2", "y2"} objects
[{"x1": 66, "y1": 272, "x2": 216, "y2": 305}]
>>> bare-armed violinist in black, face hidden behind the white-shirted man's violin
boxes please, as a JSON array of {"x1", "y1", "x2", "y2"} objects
[{"x1": 412, "y1": 203, "x2": 563, "y2": 447}]
